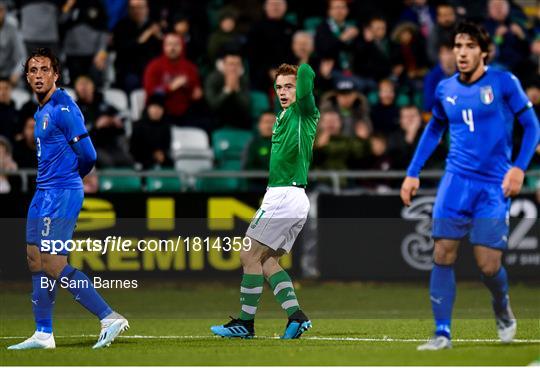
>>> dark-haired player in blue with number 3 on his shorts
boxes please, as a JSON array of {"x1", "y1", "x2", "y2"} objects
[{"x1": 8, "y1": 49, "x2": 129, "y2": 350}]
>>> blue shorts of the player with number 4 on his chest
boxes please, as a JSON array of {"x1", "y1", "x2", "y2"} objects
[{"x1": 433, "y1": 172, "x2": 510, "y2": 250}]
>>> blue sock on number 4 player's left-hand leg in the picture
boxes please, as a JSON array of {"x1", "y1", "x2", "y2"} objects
[{"x1": 429, "y1": 263, "x2": 456, "y2": 338}]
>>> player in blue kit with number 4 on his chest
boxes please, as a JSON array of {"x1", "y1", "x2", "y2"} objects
[{"x1": 401, "y1": 22, "x2": 539, "y2": 350}]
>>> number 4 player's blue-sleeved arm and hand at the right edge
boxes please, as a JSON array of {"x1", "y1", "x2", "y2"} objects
[{"x1": 503, "y1": 73, "x2": 540, "y2": 196}]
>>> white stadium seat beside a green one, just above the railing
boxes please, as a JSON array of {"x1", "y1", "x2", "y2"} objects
[{"x1": 171, "y1": 126, "x2": 214, "y2": 172}]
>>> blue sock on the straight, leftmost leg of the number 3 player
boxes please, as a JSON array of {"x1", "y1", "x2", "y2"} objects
[{"x1": 31, "y1": 271, "x2": 56, "y2": 333}]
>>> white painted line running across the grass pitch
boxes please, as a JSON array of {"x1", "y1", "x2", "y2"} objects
[{"x1": 0, "y1": 335, "x2": 540, "y2": 344}]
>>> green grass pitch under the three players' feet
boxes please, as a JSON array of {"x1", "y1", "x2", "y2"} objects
[{"x1": 0, "y1": 280, "x2": 540, "y2": 365}]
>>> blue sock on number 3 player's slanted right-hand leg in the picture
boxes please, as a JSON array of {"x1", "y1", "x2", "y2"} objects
[{"x1": 59, "y1": 265, "x2": 112, "y2": 320}]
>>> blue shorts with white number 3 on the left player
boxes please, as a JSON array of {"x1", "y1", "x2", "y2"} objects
[{"x1": 26, "y1": 189, "x2": 84, "y2": 255}]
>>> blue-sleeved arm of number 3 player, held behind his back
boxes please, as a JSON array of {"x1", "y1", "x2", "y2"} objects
[{"x1": 57, "y1": 106, "x2": 97, "y2": 178}]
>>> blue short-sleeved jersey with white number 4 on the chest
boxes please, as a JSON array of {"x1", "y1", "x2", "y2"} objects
[{"x1": 433, "y1": 67, "x2": 532, "y2": 183}]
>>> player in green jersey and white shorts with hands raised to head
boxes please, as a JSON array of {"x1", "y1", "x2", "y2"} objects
[{"x1": 211, "y1": 64, "x2": 320, "y2": 339}]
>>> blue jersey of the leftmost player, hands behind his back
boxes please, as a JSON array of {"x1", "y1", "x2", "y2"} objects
[{"x1": 34, "y1": 88, "x2": 88, "y2": 189}]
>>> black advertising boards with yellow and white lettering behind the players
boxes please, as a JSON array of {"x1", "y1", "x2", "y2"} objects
[{"x1": 0, "y1": 193, "x2": 540, "y2": 281}]
